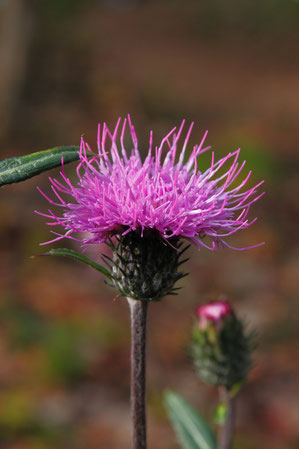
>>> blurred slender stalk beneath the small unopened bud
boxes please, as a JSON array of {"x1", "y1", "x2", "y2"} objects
[{"x1": 218, "y1": 387, "x2": 236, "y2": 449}]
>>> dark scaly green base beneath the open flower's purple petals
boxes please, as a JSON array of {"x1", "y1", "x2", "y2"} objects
[{"x1": 111, "y1": 230, "x2": 187, "y2": 301}]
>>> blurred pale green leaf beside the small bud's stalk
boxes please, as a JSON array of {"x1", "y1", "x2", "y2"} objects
[{"x1": 164, "y1": 391, "x2": 217, "y2": 449}]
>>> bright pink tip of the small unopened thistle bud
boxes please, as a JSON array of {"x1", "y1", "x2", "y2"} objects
[{"x1": 196, "y1": 300, "x2": 233, "y2": 329}]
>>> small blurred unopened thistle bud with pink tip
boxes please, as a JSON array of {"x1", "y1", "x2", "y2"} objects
[{"x1": 191, "y1": 301, "x2": 252, "y2": 390}]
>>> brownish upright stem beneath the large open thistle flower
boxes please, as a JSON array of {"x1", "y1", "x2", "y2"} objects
[{"x1": 127, "y1": 298, "x2": 148, "y2": 449}]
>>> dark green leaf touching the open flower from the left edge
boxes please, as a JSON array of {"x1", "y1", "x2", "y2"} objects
[{"x1": 0, "y1": 146, "x2": 93, "y2": 186}]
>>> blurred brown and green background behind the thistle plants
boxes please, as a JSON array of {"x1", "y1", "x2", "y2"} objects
[{"x1": 0, "y1": 0, "x2": 299, "y2": 449}]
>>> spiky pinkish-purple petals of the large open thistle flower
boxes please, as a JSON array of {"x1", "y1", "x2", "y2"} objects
[{"x1": 37, "y1": 117, "x2": 262, "y2": 250}]
